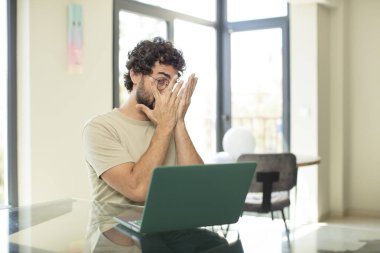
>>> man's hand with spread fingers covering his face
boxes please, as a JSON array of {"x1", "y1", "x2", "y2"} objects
[{"x1": 136, "y1": 75, "x2": 183, "y2": 130}]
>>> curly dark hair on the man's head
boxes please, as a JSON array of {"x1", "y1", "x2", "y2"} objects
[{"x1": 124, "y1": 37, "x2": 186, "y2": 92}]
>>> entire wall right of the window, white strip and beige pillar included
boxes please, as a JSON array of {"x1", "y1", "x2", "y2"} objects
[{"x1": 290, "y1": 0, "x2": 380, "y2": 218}]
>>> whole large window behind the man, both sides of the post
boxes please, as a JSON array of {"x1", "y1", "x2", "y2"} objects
[{"x1": 114, "y1": 0, "x2": 290, "y2": 158}]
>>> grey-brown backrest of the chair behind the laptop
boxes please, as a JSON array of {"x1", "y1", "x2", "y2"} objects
[{"x1": 238, "y1": 153, "x2": 298, "y2": 192}]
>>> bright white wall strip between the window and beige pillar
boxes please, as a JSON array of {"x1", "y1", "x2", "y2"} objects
[{"x1": 290, "y1": 4, "x2": 319, "y2": 224}]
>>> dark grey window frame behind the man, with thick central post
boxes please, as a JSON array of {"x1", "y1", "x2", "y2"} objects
[{"x1": 112, "y1": 0, "x2": 290, "y2": 152}]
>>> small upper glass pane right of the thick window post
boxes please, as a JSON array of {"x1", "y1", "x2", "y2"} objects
[{"x1": 227, "y1": 0, "x2": 288, "y2": 22}]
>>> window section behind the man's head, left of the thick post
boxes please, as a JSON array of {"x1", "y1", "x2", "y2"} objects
[{"x1": 114, "y1": 0, "x2": 216, "y2": 160}]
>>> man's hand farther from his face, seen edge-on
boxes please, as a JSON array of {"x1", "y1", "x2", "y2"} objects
[{"x1": 177, "y1": 73, "x2": 198, "y2": 121}]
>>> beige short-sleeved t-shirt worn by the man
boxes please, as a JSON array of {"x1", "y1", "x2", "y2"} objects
[{"x1": 83, "y1": 109, "x2": 176, "y2": 204}]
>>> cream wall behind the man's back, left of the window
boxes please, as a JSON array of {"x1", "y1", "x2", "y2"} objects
[{"x1": 18, "y1": 0, "x2": 112, "y2": 205}]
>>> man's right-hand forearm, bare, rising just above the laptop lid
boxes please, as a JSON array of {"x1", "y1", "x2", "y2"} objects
[{"x1": 174, "y1": 121, "x2": 203, "y2": 165}]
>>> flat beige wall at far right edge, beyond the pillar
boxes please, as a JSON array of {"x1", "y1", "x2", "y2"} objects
[{"x1": 345, "y1": 0, "x2": 380, "y2": 217}]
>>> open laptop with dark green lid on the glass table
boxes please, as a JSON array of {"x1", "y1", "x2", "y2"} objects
[{"x1": 114, "y1": 162, "x2": 256, "y2": 233}]
